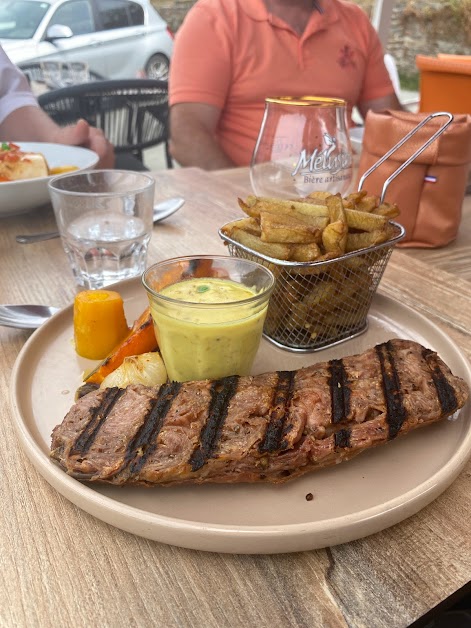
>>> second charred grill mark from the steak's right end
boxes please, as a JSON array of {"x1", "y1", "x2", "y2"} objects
[{"x1": 376, "y1": 341, "x2": 407, "y2": 439}]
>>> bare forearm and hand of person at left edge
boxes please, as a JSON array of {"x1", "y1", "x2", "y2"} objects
[{"x1": 0, "y1": 106, "x2": 114, "y2": 168}]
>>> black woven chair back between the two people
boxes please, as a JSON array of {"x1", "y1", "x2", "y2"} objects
[{"x1": 38, "y1": 79, "x2": 173, "y2": 168}]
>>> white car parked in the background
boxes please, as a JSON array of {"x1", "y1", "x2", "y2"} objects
[{"x1": 0, "y1": 0, "x2": 173, "y2": 79}]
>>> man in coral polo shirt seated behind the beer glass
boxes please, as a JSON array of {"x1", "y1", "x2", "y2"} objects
[{"x1": 170, "y1": 0, "x2": 401, "y2": 170}]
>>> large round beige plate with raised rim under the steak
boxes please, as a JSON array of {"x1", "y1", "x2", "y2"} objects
[{"x1": 11, "y1": 280, "x2": 471, "y2": 553}]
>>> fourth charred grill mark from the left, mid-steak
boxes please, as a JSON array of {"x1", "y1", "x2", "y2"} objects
[{"x1": 259, "y1": 371, "x2": 296, "y2": 453}]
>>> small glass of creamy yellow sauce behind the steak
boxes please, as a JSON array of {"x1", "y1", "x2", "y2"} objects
[{"x1": 143, "y1": 255, "x2": 274, "y2": 381}]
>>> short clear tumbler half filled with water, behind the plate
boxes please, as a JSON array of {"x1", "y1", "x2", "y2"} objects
[{"x1": 49, "y1": 170, "x2": 155, "y2": 290}]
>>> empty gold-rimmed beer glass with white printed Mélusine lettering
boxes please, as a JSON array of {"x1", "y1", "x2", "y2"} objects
[{"x1": 250, "y1": 96, "x2": 353, "y2": 198}]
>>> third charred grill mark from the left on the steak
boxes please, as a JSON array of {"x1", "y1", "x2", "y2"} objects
[{"x1": 189, "y1": 375, "x2": 239, "y2": 471}]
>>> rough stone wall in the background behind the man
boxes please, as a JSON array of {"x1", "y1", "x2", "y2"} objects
[{"x1": 152, "y1": 0, "x2": 471, "y2": 76}]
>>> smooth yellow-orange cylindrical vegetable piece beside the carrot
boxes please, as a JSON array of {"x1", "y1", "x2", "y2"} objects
[{"x1": 74, "y1": 290, "x2": 129, "y2": 360}]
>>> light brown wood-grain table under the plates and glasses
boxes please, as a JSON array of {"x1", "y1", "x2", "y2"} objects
[{"x1": 0, "y1": 169, "x2": 471, "y2": 628}]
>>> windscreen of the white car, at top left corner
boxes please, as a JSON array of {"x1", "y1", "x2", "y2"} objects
[{"x1": 0, "y1": 0, "x2": 50, "y2": 39}]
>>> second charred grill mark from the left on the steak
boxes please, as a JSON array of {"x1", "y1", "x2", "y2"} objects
[{"x1": 120, "y1": 382, "x2": 181, "y2": 475}]
